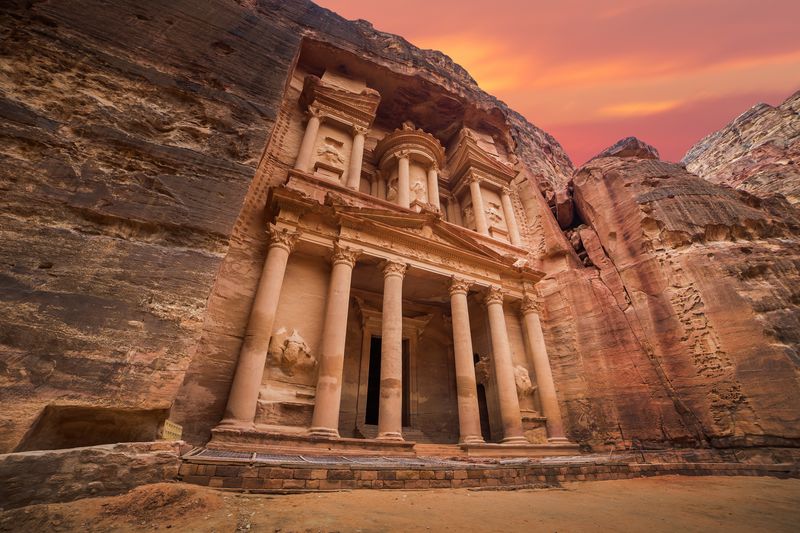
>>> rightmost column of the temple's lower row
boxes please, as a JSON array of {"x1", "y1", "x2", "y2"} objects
[{"x1": 521, "y1": 295, "x2": 567, "y2": 442}]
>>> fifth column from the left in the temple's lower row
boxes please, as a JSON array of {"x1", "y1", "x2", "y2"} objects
[{"x1": 485, "y1": 287, "x2": 528, "y2": 444}]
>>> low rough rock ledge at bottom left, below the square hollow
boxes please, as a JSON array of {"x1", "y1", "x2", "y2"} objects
[{"x1": 0, "y1": 441, "x2": 182, "y2": 509}]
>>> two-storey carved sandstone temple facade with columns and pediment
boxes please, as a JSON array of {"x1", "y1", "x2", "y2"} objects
[{"x1": 210, "y1": 46, "x2": 577, "y2": 455}]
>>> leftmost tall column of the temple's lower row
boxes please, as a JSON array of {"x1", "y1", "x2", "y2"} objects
[{"x1": 220, "y1": 225, "x2": 299, "y2": 426}]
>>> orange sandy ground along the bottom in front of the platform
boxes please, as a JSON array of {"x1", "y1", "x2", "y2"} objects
[{"x1": 0, "y1": 476, "x2": 800, "y2": 533}]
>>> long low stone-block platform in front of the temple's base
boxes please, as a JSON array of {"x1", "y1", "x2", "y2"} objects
[{"x1": 178, "y1": 449, "x2": 800, "y2": 492}]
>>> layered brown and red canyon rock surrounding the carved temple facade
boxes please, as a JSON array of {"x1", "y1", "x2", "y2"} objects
[{"x1": 0, "y1": 0, "x2": 800, "y2": 453}]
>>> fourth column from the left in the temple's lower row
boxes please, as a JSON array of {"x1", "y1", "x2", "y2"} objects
[{"x1": 450, "y1": 277, "x2": 483, "y2": 443}]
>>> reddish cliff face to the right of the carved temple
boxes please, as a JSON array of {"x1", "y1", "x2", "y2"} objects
[{"x1": 541, "y1": 158, "x2": 800, "y2": 446}]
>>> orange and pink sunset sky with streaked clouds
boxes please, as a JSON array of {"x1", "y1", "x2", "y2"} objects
[{"x1": 317, "y1": 0, "x2": 800, "y2": 164}]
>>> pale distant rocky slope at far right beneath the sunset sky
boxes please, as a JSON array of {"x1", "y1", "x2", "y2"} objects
[{"x1": 683, "y1": 91, "x2": 800, "y2": 204}]
